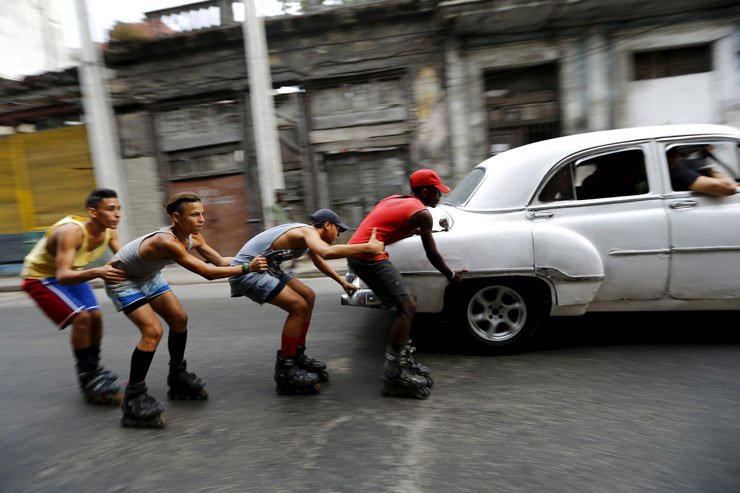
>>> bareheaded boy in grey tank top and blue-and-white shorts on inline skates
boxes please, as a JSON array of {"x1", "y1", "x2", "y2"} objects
[{"x1": 106, "y1": 192, "x2": 267, "y2": 427}]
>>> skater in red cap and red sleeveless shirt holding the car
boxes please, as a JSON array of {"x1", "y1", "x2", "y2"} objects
[{"x1": 347, "y1": 169, "x2": 466, "y2": 399}]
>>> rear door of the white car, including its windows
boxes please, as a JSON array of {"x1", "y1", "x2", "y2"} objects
[{"x1": 527, "y1": 142, "x2": 669, "y2": 301}]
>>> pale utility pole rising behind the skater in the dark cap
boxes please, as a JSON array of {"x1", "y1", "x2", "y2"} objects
[{"x1": 242, "y1": 0, "x2": 285, "y2": 224}]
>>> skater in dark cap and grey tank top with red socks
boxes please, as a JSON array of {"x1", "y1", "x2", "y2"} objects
[{"x1": 229, "y1": 209, "x2": 384, "y2": 394}]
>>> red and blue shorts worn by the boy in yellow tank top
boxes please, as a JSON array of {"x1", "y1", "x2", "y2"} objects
[{"x1": 21, "y1": 277, "x2": 100, "y2": 330}]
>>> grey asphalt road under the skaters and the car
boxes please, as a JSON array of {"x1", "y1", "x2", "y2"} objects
[{"x1": 0, "y1": 279, "x2": 740, "y2": 492}]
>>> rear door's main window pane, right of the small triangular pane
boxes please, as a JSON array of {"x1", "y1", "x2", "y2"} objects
[{"x1": 573, "y1": 149, "x2": 649, "y2": 200}]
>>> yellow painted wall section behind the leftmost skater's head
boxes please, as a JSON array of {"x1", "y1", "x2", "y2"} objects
[{"x1": 0, "y1": 126, "x2": 95, "y2": 234}]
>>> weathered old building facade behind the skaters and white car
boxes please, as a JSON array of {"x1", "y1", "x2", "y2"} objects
[{"x1": 0, "y1": 0, "x2": 740, "y2": 266}]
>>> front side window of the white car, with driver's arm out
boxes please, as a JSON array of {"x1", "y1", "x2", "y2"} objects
[{"x1": 666, "y1": 141, "x2": 740, "y2": 192}]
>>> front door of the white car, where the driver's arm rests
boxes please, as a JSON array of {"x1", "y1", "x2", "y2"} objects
[{"x1": 662, "y1": 139, "x2": 740, "y2": 300}]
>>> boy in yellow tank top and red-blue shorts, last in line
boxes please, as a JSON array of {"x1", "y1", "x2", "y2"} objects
[{"x1": 21, "y1": 188, "x2": 126, "y2": 404}]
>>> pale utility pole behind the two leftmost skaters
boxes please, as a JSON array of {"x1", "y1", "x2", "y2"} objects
[{"x1": 77, "y1": 0, "x2": 133, "y2": 243}]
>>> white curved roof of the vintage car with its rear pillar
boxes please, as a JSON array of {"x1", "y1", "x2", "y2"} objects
[{"x1": 462, "y1": 124, "x2": 740, "y2": 210}]
